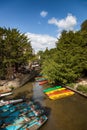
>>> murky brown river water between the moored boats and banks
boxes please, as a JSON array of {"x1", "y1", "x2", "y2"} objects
[{"x1": 13, "y1": 82, "x2": 87, "y2": 130}]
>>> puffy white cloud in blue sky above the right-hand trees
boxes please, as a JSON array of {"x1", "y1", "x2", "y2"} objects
[{"x1": 48, "y1": 14, "x2": 77, "y2": 31}]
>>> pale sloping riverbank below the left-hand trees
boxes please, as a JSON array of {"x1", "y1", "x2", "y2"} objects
[{"x1": 0, "y1": 71, "x2": 37, "y2": 93}]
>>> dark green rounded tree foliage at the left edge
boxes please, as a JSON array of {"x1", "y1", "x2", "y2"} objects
[{"x1": 0, "y1": 28, "x2": 32, "y2": 77}]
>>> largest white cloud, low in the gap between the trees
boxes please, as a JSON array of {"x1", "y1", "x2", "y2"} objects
[{"x1": 26, "y1": 33, "x2": 57, "y2": 53}]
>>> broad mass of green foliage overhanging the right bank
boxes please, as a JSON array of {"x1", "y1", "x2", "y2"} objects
[{"x1": 42, "y1": 20, "x2": 87, "y2": 84}]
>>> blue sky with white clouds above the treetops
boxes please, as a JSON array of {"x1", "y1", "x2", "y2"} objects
[{"x1": 0, "y1": 0, "x2": 87, "y2": 52}]
